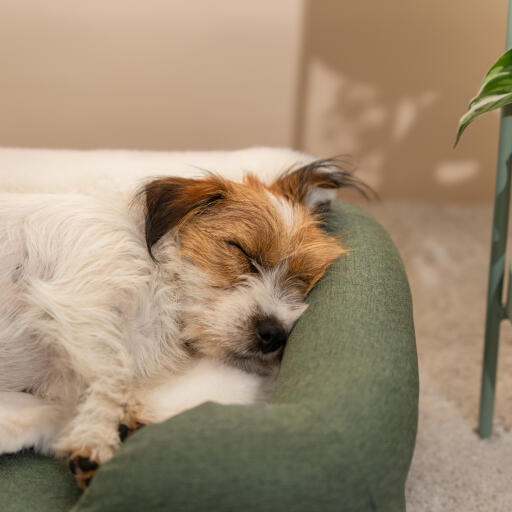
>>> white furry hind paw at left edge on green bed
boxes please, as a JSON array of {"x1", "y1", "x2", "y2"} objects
[{"x1": 0, "y1": 391, "x2": 67, "y2": 455}]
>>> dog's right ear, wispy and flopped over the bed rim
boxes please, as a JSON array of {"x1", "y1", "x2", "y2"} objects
[{"x1": 271, "y1": 157, "x2": 371, "y2": 210}]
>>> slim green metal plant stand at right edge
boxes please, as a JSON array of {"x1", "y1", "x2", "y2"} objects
[{"x1": 478, "y1": 1, "x2": 512, "y2": 438}]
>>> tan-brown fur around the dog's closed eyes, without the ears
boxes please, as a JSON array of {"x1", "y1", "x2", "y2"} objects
[{"x1": 167, "y1": 175, "x2": 343, "y2": 293}]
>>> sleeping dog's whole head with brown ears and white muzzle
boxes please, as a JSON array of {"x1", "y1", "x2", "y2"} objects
[{"x1": 138, "y1": 160, "x2": 364, "y2": 374}]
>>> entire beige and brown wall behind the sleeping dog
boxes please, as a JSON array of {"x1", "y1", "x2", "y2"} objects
[{"x1": 0, "y1": 0, "x2": 507, "y2": 201}]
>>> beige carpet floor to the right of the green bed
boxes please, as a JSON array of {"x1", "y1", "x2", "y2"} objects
[{"x1": 365, "y1": 203, "x2": 512, "y2": 512}]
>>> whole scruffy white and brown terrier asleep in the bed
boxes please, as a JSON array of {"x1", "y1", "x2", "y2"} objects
[{"x1": 0, "y1": 160, "x2": 362, "y2": 488}]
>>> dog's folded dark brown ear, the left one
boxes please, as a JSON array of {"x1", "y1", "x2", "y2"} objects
[{"x1": 141, "y1": 175, "x2": 227, "y2": 257}]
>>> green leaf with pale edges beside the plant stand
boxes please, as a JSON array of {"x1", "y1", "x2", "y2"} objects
[{"x1": 453, "y1": 49, "x2": 512, "y2": 147}]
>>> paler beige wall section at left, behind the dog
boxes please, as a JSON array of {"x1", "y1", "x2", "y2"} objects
[{"x1": 0, "y1": 0, "x2": 301, "y2": 149}]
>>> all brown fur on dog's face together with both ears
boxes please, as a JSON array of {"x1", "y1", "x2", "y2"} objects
[{"x1": 139, "y1": 159, "x2": 366, "y2": 293}]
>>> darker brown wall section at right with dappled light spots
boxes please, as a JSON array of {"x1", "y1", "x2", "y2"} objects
[{"x1": 294, "y1": 0, "x2": 507, "y2": 202}]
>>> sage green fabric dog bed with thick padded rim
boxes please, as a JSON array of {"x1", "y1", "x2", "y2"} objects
[{"x1": 0, "y1": 202, "x2": 418, "y2": 512}]
